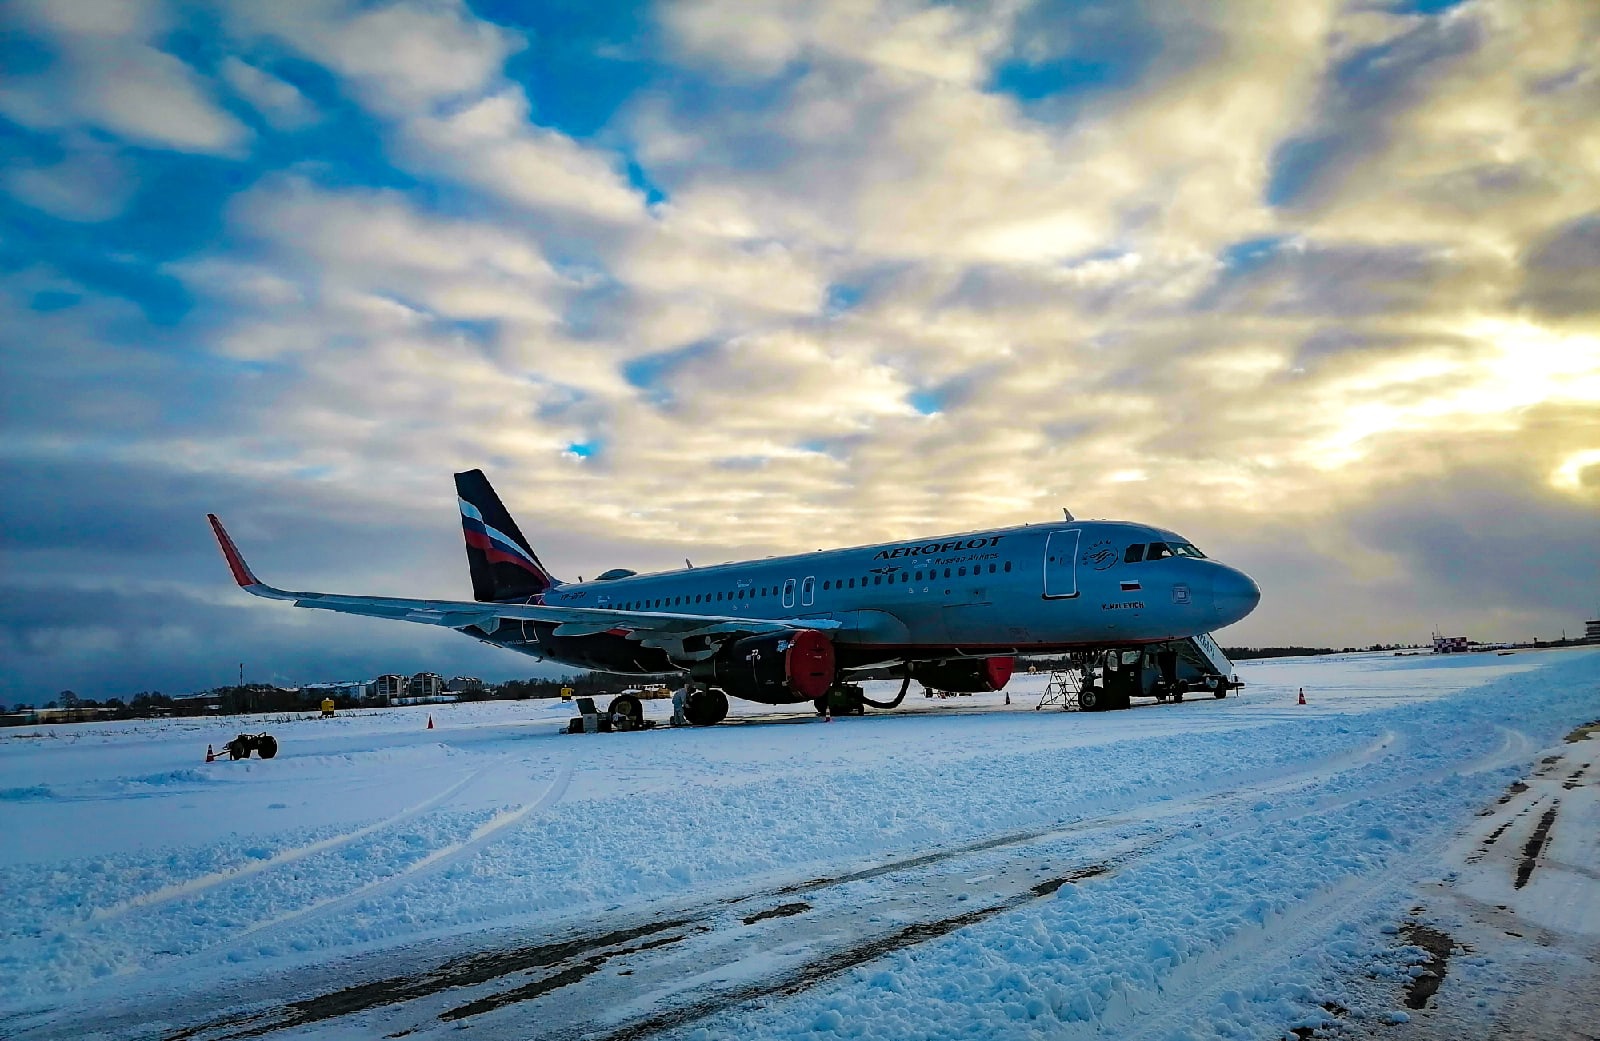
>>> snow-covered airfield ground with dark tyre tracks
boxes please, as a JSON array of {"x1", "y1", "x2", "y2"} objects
[{"x1": 0, "y1": 651, "x2": 1600, "y2": 1039}]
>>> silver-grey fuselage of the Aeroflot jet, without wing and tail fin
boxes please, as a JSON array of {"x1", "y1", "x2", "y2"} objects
[{"x1": 472, "y1": 521, "x2": 1261, "y2": 684}]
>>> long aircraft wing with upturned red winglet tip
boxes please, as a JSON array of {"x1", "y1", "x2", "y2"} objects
[{"x1": 206, "y1": 513, "x2": 843, "y2": 660}]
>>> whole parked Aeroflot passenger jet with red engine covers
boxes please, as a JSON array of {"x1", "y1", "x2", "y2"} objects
[{"x1": 210, "y1": 470, "x2": 1261, "y2": 724}]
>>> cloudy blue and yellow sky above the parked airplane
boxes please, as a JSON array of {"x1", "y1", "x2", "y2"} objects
[{"x1": 0, "y1": 0, "x2": 1600, "y2": 704}]
